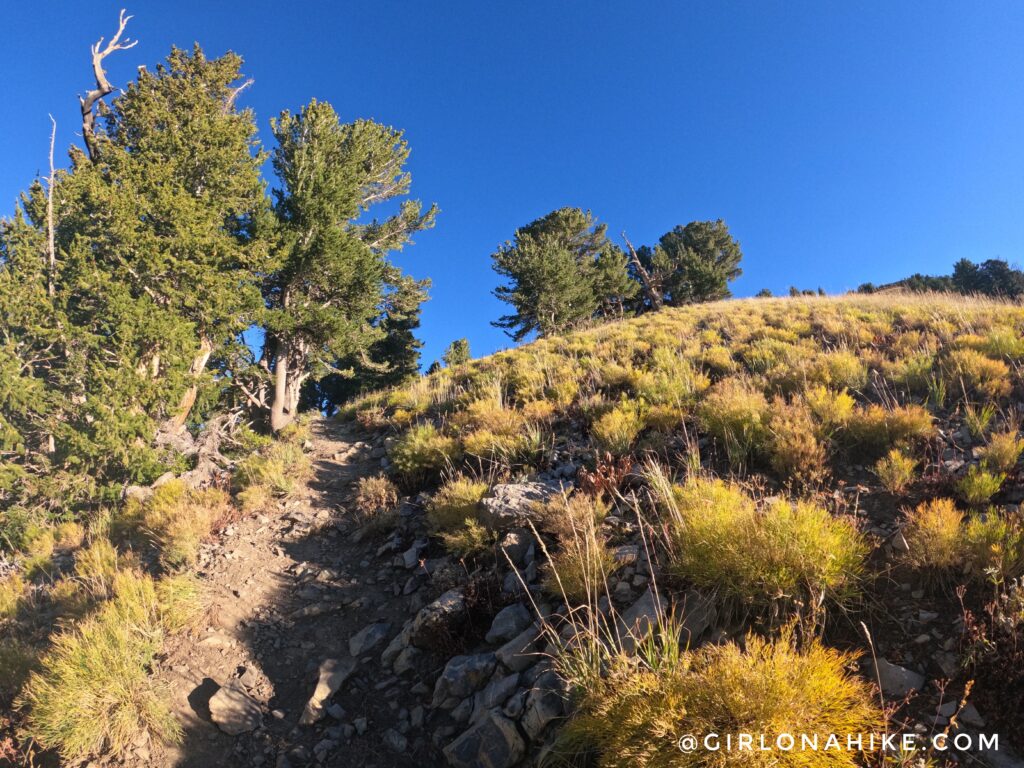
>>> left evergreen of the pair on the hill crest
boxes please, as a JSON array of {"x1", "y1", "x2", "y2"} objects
[{"x1": 492, "y1": 208, "x2": 637, "y2": 341}]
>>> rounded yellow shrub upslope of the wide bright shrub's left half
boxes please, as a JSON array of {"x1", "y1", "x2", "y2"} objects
[{"x1": 698, "y1": 378, "x2": 768, "y2": 465}]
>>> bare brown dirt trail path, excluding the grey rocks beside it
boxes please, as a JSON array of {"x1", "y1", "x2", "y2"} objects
[{"x1": 153, "y1": 420, "x2": 434, "y2": 768}]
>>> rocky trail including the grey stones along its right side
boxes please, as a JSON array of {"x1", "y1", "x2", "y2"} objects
[{"x1": 148, "y1": 421, "x2": 561, "y2": 768}]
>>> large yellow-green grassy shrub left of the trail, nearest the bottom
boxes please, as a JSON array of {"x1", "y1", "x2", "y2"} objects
[{"x1": 20, "y1": 571, "x2": 190, "y2": 761}]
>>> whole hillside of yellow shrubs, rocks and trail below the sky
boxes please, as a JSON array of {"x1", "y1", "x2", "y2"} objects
[{"x1": 6, "y1": 295, "x2": 1024, "y2": 768}]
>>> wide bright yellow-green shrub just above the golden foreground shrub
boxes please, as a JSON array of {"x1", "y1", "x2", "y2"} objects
[{"x1": 663, "y1": 477, "x2": 867, "y2": 605}]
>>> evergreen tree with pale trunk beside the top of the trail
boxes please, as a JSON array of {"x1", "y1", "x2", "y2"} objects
[{"x1": 255, "y1": 100, "x2": 436, "y2": 431}]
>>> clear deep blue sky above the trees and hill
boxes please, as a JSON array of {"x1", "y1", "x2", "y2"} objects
[{"x1": 0, "y1": 0, "x2": 1024, "y2": 364}]
